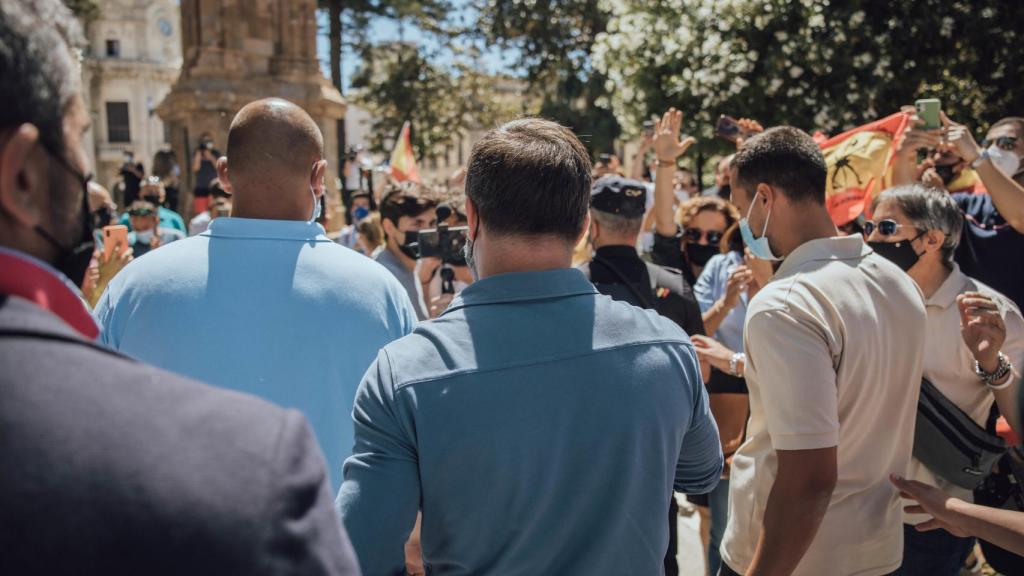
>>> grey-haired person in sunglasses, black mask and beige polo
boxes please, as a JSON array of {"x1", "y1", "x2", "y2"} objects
[{"x1": 864, "y1": 184, "x2": 1024, "y2": 576}]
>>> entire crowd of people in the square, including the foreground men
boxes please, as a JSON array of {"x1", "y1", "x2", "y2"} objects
[{"x1": 0, "y1": 0, "x2": 1024, "y2": 576}]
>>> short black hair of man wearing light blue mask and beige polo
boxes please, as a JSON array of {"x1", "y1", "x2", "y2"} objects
[{"x1": 732, "y1": 126, "x2": 828, "y2": 204}]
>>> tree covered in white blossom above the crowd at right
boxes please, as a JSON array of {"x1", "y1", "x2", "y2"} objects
[{"x1": 592, "y1": 0, "x2": 1024, "y2": 147}]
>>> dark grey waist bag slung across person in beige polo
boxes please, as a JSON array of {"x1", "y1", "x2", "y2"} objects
[{"x1": 913, "y1": 379, "x2": 1007, "y2": 490}]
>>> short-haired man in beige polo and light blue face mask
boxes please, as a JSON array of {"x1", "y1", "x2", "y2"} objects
[{"x1": 721, "y1": 126, "x2": 927, "y2": 576}]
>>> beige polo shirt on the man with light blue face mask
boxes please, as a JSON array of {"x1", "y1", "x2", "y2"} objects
[{"x1": 722, "y1": 236, "x2": 927, "y2": 576}]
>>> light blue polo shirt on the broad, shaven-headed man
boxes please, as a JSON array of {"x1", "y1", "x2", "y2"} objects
[{"x1": 95, "y1": 217, "x2": 416, "y2": 488}]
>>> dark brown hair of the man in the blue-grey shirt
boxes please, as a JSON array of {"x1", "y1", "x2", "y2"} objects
[{"x1": 466, "y1": 118, "x2": 591, "y2": 241}]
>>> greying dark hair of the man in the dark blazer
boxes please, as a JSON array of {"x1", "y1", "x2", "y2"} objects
[{"x1": 0, "y1": 0, "x2": 82, "y2": 158}]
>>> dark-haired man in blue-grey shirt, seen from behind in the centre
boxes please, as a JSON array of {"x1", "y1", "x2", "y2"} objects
[{"x1": 338, "y1": 119, "x2": 722, "y2": 576}]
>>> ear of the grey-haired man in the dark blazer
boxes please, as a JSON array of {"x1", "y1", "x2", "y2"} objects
[{"x1": 0, "y1": 124, "x2": 46, "y2": 228}]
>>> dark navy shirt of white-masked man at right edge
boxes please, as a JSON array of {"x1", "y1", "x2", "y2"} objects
[{"x1": 952, "y1": 192, "x2": 1024, "y2": 307}]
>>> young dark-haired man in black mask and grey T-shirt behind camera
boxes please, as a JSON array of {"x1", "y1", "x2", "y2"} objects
[{"x1": 376, "y1": 187, "x2": 441, "y2": 320}]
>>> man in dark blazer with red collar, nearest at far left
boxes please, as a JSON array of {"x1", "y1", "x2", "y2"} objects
[{"x1": 0, "y1": 0, "x2": 358, "y2": 575}]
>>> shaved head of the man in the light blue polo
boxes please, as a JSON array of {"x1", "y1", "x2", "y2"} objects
[{"x1": 218, "y1": 98, "x2": 326, "y2": 219}]
